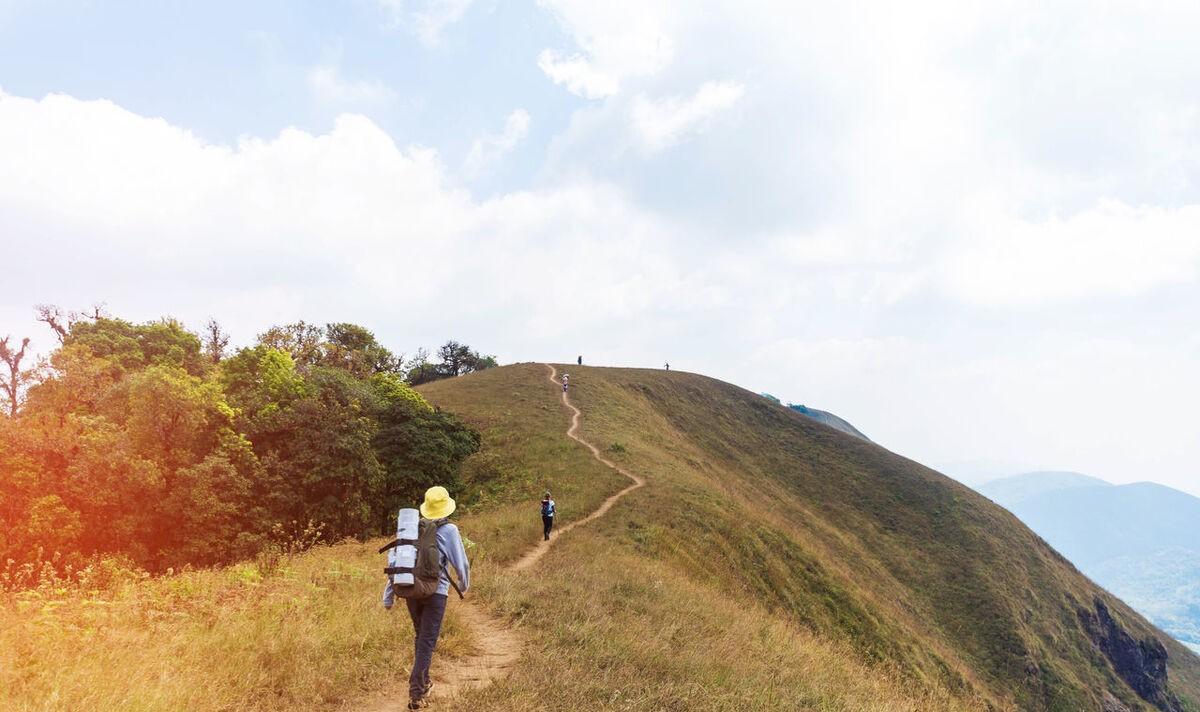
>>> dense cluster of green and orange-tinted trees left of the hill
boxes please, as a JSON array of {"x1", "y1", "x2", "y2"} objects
[{"x1": 0, "y1": 310, "x2": 496, "y2": 570}]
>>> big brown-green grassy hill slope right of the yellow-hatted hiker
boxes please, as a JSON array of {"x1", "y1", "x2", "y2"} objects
[{"x1": 422, "y1": 365, "x2": 1200, "y2": 710}]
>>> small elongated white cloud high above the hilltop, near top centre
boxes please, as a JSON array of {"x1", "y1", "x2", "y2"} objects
[{"x1": 630, "y1": 82, "x2": 745, "y2": 151}]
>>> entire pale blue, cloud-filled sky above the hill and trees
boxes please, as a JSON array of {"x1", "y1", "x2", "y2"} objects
[{"x1": 0, "y1": 0, "x2": 1200, "y2": 495}]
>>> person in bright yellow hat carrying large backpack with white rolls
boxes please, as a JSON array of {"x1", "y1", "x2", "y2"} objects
[{"x1": 379, "y1": 486, "x2": 470, "y2": 710}]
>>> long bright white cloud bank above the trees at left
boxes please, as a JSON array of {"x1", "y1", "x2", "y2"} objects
[{"x1": 0, "y1": 95, "x2": 695, "y2": 350}]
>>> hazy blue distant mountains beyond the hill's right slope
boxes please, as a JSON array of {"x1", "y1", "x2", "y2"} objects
[{"x1": 977, "y1": 472, "x2": 1200, "y2": 651}]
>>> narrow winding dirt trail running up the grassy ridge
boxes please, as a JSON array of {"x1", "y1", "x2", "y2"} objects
[{"x1": 355, "y1": 364, "x2": 646, "y2": 712}]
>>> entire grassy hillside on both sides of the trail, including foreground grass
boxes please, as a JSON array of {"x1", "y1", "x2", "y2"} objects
[{"x1": 0, "y1": 364, "x2": 1200, "y2": 712}]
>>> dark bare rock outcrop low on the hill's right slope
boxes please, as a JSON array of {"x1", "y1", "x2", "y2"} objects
[{"x1": 1079, "y1": 598, "x2": 1183, "y2": 712}]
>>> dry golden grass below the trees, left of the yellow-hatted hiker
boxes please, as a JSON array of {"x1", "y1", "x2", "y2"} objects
[{"x1": 0, "y1": 544, "x2": 469, "y2": 712}]
